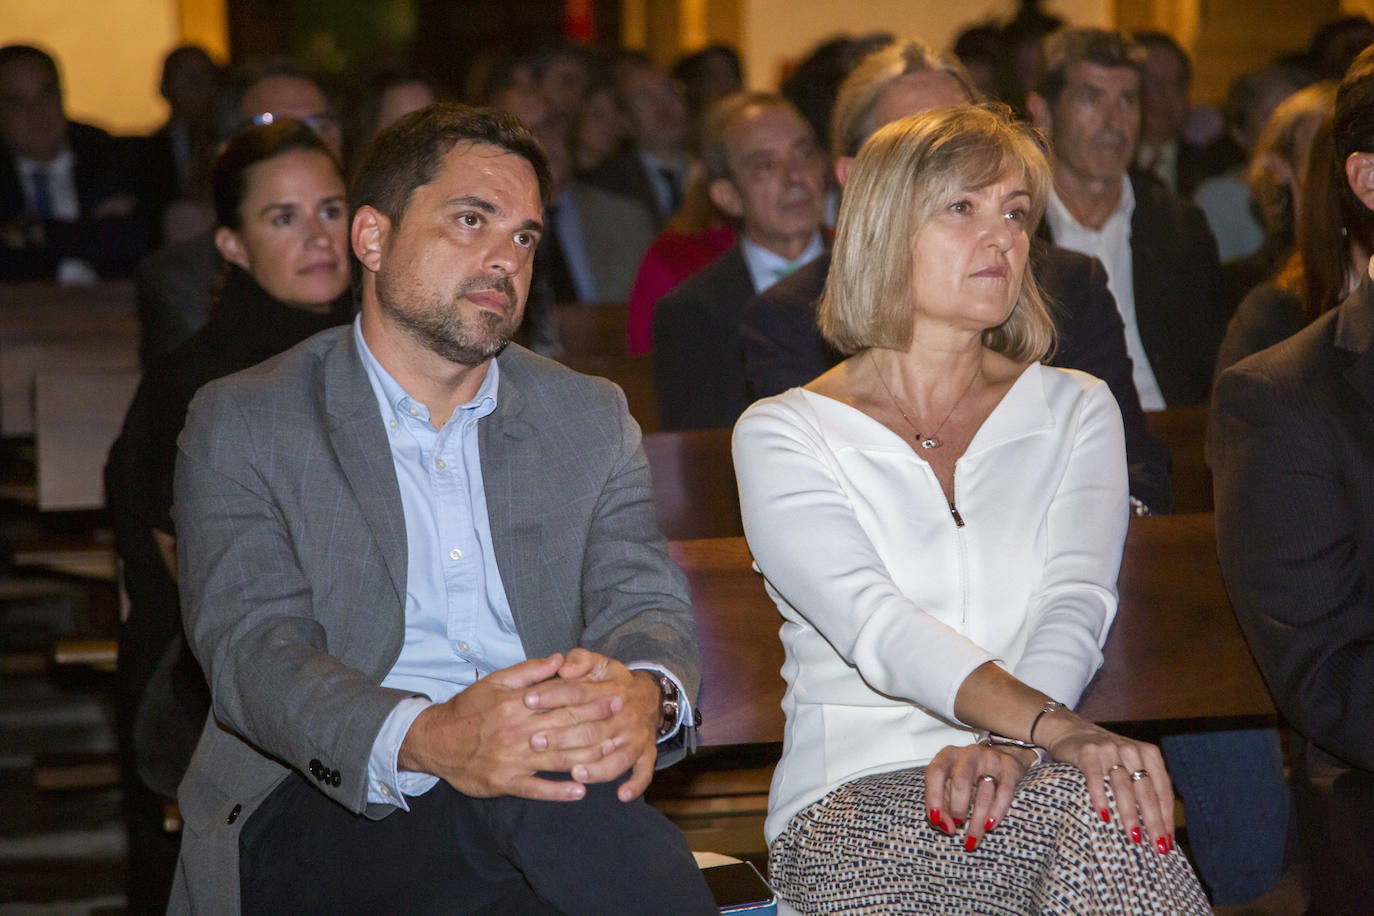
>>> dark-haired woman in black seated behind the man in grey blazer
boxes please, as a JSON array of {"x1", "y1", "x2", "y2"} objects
[{"x1": 106, "y1": 119, "x2": 353, "y2": 913}]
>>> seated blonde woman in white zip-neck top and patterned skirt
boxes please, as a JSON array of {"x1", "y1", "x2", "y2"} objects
[{"x1": 734, "y1": 106, "x2": 1209, "y2": 913}]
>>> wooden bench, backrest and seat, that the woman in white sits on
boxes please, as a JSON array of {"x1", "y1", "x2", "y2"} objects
[{"x1": 650, "y1": 515, "x2": 1275, "y2": 854}]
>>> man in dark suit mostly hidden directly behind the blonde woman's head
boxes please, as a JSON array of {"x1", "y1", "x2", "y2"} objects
[{"x1": 739, "y1": 41, "x2": 1173, "y2": 512}]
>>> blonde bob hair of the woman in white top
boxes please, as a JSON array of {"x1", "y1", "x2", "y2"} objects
[{"x1": 818, "y1": 103, "x2": 1054, "y2": 363}]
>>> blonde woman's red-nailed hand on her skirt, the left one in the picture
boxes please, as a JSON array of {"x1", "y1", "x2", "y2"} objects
[{"x1": 926, "y1": 744, "x2": 1032, "y2": 853}]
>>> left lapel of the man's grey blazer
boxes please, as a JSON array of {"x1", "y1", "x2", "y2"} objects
[{"x1": 324, "y1": 333, "x2": 407, "y2": 607}]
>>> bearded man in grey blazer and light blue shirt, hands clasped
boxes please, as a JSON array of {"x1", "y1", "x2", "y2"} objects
[{"x1": 170, "y1": 106, "x2": 716, "y2": 913}]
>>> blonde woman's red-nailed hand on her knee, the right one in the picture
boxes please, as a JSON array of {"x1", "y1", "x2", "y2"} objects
[{"x1": 1037, "y1": 714, "x2": 1173, "y2": 853}]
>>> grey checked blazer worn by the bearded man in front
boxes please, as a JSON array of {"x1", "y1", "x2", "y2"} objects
[{"x1": 170, "y1": 325, "x2": 701, "y2": 913}]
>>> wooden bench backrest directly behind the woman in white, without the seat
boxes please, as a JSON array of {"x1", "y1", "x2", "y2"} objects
[{"x1": 681, "y1": 515, "x2": 1274, "y2": 746}]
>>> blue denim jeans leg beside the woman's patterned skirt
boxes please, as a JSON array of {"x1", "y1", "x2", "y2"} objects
[{"x1": 1160, "y1": 728, "x2": 1289, "y2": 906}]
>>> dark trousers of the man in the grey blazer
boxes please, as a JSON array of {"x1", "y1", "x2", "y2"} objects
[{"x1": 239, "y1": 773, "x2": 720, "y2": 916}]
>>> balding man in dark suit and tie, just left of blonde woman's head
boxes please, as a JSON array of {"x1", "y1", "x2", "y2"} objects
[{"x1": 654, "y1": 92, "x2": 826, "y2": 430}]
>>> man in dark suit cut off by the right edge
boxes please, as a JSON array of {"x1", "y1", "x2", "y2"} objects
[{"x1": 1209, "y1": 48, "x2": 1374, "y2": 916}]
